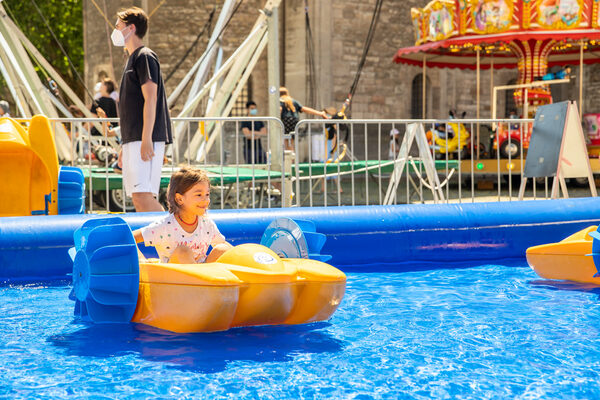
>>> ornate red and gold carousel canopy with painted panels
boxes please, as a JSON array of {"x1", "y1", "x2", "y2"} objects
[{"x1": 394, "y1": 0, "x2": 600, "y2": 69}]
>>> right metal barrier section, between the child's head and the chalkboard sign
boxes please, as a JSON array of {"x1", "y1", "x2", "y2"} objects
[{"x1": 293, "y1": 119, "x2": 592, "y2": 206}]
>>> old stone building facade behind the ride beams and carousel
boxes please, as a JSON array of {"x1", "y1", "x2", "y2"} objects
[{"x1": 83, "y1": 0, "x2": 600, "y2": 119}]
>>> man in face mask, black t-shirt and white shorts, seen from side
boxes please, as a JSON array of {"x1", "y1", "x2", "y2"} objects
[{"x1": 111, "y1": 7, "x2": 173, "y2": 212}]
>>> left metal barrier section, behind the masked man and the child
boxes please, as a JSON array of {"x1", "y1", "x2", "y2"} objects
[{"x1": 38, "y1": 117, "x2": 291, "y2": 212}]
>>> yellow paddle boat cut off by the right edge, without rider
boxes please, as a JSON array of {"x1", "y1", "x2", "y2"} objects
[{"x1": 527, "y1": 226, "x2": 600, "y2": 285}]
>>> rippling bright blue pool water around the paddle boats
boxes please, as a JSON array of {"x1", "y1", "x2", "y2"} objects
[{"x1": 0, "y1": 264, "x2": 600, "y2": 400}]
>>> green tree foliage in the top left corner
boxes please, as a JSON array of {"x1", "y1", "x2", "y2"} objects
[{"x1": 2, "y1": 0, "x2": 84, "y2": 96}]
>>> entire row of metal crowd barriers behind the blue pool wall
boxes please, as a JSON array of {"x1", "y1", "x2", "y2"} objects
[{"x1": 30, "y1": 117, "x2": 592, "y2": 211}]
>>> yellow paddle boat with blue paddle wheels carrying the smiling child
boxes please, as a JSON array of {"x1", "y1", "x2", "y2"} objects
[{"x1": 71, "y1": 217, "x2": 346, "y2": 333}]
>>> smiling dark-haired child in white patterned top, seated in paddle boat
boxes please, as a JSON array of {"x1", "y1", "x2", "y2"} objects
[{"x1": 133, "y1": 168, "x2": 232, "y2": 264}]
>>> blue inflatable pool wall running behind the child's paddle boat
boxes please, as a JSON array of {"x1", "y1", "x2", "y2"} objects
[{"x1": 0, "y1": 198, "x2": 600, "y2": 281}]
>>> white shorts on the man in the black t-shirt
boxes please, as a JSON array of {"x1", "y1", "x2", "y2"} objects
[{"x1": 123, "y1": 140, "x2": 165, "y2": 197}]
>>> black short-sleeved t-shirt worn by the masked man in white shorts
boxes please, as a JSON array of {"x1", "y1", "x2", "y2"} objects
[{"x1": 119, "y1": 46, "x2": 173, "y2": 144}]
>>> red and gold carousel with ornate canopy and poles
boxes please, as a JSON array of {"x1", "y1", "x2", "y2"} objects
[{"x1": 394, "y1": 0, "x2": 600, "y2": 158}]
